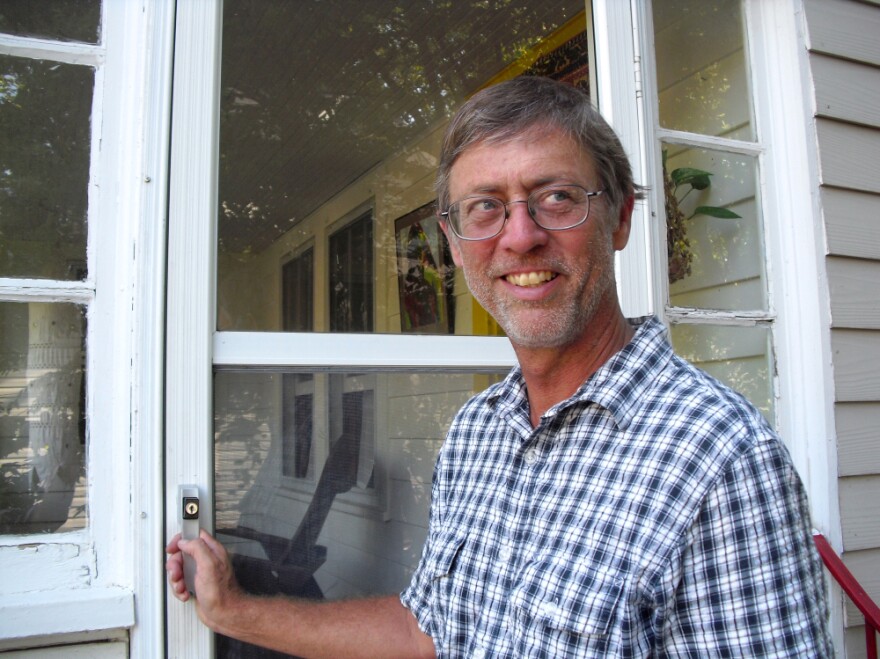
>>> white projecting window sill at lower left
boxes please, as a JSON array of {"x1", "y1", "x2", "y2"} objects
[{"x1": 0, "y1": 588, "x2": 134, "y2": 639}]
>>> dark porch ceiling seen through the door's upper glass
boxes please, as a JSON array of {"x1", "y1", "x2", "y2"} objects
[{"x1": 218, "y1": 0, "x2": 583, "y2": 253}]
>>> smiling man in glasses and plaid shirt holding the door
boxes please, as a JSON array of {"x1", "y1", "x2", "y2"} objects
[{"x1": 167, "y1": 78, "x2": 832, "y2": 658}]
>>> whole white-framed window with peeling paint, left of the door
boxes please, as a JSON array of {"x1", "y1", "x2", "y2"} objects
[{"x1": 0, "y1": 0, "x2": 158, "y2": 645}]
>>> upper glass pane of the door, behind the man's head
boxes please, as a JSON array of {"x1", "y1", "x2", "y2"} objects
[{"x1": 217, "y1": 0, "x2": 589, "y2": 334}]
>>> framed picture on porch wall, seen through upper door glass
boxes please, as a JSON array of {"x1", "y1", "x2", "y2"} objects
[{"x1": 394, "y1": 202, "x2": 455, "y2": 334}]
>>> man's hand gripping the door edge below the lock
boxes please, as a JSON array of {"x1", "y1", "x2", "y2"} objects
[{"x1": 165, "y1": 530, "x2": 247, "y2": 633}]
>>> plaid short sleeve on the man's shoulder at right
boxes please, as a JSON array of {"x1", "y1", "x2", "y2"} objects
[{"x1": 662, "y1": 436, "x2": 833, "y2": 657}]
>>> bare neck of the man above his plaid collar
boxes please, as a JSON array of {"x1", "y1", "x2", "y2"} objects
[{"x1": 514, "y1": 308, "x2": 634, "y2": 428}]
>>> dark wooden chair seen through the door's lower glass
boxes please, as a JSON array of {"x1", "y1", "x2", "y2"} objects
[{"x1": 217, "y1": 422, "x2": 361, "y2": 659}]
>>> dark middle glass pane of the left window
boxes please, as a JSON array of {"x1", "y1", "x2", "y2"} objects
[{"x1": 0, "y1": 55, "x2": 95, "y2": 280}]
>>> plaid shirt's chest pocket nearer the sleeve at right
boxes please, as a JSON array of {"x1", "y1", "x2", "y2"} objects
[{"x1": 512, "y1": 558, "x2": 624, "y2": 638}]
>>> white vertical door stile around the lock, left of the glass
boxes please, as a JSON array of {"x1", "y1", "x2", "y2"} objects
[{"x1": 165, "y1": 0, "x2": 222, "y2": 657}]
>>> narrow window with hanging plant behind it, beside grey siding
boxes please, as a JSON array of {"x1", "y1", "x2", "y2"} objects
[{"x1": 651, "y1": 0, "x2": 776, "y2": 422}]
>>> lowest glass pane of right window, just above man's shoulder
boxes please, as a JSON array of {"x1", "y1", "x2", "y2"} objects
[{"x1": 670, "y1": 324, "x2": 775, "y2": 424}]
